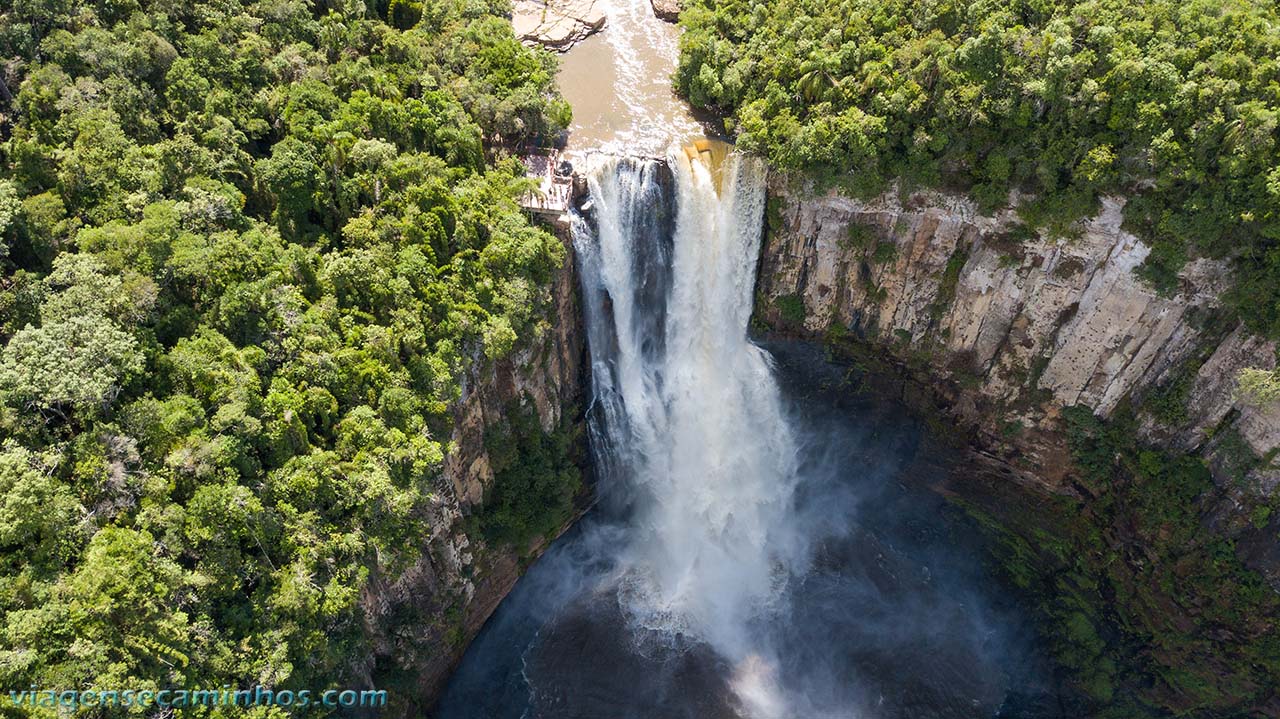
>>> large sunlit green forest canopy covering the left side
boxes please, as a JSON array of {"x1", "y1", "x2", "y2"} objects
[{"x1": 0, "y1": 0, "x2": 568, "y2": 706}]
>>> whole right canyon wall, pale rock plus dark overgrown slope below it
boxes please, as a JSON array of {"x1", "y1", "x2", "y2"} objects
[{"x1": 755, "y1": 177, "x2": 1280, "y2": 716}]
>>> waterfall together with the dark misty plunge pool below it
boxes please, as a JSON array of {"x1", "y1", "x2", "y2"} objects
[{"x1": 436, "y1": 145, "x2": 1069, "y2": 719}]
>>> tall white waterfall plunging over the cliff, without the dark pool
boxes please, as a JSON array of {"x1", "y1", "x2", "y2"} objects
[{"x1": 575, "y1": 154, "x2": 806, "y2": 702}]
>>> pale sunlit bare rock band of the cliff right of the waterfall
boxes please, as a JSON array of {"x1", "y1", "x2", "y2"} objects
[{"x1": 758, "y1": 178, "x2": 1280, "y2": 495}]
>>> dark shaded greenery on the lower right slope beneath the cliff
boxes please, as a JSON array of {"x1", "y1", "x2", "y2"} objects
[{"x1": 1034, "y1": 407, "x2": 1280, "y2": 718}]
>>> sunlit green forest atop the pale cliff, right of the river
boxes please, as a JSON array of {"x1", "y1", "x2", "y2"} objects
[{"x1": 676, "y1": 0, "x2": 1280, "y2": 336}]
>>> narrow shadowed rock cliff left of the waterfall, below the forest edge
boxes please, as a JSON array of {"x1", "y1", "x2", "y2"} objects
[{"x1": 361, "y1": 229, "x2": 585, "y2": 716}]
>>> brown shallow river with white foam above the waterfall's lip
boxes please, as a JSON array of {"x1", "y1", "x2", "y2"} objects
[{"x1": 558, "y1": 0, "x2": 704, "y2": 156}]
